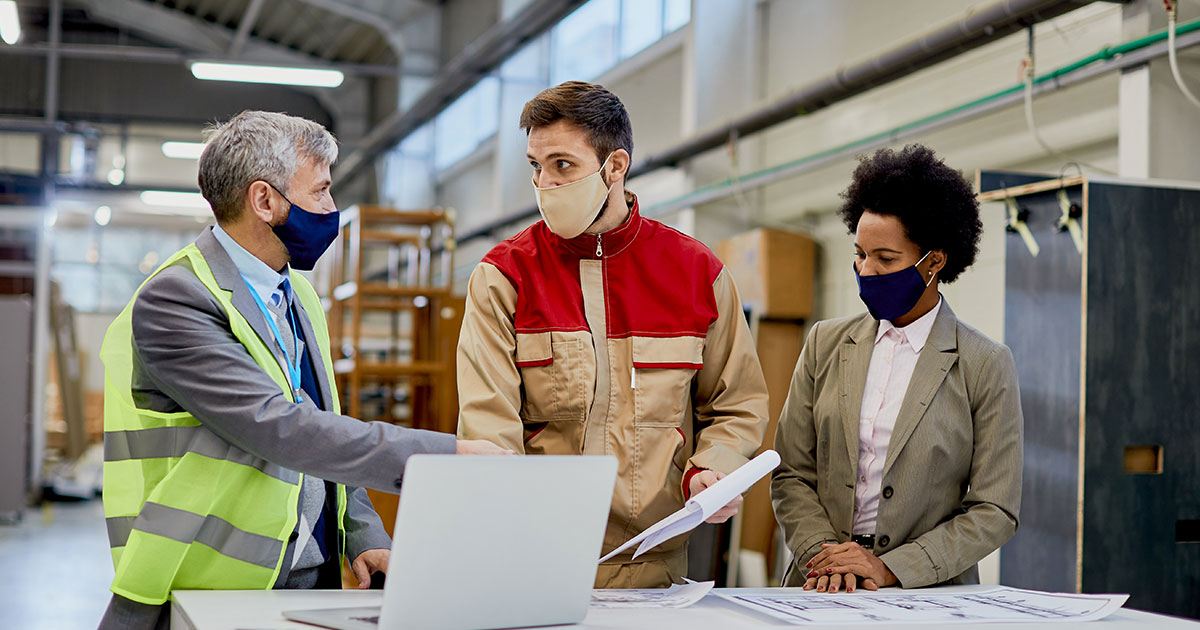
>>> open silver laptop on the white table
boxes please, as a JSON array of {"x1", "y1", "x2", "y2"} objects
[{"x1": 283, "y1": 455, "x2": 617, "y2": 630}]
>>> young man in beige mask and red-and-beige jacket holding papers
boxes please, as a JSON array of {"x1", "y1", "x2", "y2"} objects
[{"x1": 457, "y1": 82, "x2": 767, "y2": 588}]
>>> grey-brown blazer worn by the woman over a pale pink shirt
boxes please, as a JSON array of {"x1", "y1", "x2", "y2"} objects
[{"x1": 770, "y1": 300, "x2": 1022, "y2": 588}]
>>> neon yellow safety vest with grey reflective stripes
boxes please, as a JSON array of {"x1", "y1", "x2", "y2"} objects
[{"x1": 101, "y1": 244, "x2": 346, "y2": 605}]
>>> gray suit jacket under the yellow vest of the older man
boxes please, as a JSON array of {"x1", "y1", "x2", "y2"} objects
[{"x1": 132, "y1": 229, "x2": 455, "y2": 573}]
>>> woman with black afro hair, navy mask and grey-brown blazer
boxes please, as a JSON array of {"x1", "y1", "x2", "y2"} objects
[{"x1": 772, "y1": 144, "x2": 1021, "y2": 593}]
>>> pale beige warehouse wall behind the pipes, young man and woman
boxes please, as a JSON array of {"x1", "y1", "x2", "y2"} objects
[{"x1": 398, "y1": 0, "x2": 1200, "y2": 581}]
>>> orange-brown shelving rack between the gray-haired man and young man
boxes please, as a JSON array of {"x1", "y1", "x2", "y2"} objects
[{"x1": 328, "y1": 205, "x2": 463, "y2": 432}]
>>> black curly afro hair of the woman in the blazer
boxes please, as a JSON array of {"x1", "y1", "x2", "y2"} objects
[{"x1": 838, "y1": 144, "x2": 983, "y2": 282}]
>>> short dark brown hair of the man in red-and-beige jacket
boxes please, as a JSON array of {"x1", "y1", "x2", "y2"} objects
[{"x1": 521, "y1": 80, "x2": 634, "y2": 168}]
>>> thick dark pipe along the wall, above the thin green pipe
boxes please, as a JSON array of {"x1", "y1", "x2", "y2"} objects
[{"x1": 458, "y1": 0, "x2": 1094, "y2": 247}]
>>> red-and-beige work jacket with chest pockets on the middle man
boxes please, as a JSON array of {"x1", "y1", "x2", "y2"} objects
[{"x1": 457, "y1": 198, "x2": 768, "y2": 580}]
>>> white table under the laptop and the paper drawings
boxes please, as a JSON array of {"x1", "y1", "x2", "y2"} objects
[{"x1": 170, "y1": 586, "x2": 1200, "y2": 630}]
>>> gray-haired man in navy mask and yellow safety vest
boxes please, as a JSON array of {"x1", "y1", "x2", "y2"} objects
[{"x1": 101, "y1": 112, "x2": 508, "y2": 629}]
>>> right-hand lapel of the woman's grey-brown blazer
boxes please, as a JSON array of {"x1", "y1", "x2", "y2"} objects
[{"x1": 883, "y1": 299, "x2": 959, "y2": 476}]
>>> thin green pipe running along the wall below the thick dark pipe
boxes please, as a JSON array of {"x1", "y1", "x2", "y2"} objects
[{"x1": 646, "y1": 19, "x2": 1200, "y2": 215}]
